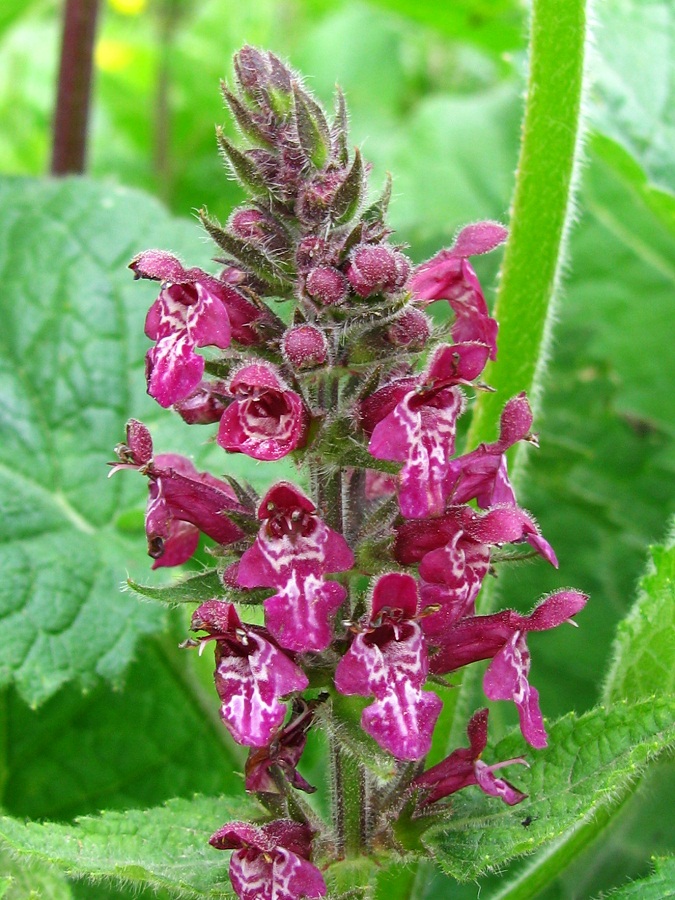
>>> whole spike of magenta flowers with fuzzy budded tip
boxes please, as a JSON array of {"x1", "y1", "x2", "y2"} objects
[{"x1": 116, "y1": 47, "x2": 586, "y2": 900}]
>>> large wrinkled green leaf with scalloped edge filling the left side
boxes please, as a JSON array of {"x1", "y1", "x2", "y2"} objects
[{"x1": 0, "y1": 179, "x2": 227, "y2": 704}]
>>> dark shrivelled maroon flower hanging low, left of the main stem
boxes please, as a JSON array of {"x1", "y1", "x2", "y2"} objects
[{"x1": 246, "y1": 697, "x2": 319, "y2": 794}]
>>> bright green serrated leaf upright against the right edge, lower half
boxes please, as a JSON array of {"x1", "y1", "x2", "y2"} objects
[{"x1": 604, "y1": 532, "x2": 675, "y2": 703}]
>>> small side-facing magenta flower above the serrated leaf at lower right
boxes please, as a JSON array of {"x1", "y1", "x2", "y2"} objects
[{"x1": 413, "y1": 709, "x2": 527, "y2": 806}]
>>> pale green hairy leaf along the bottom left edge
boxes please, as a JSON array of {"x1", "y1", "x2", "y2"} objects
[{"x1": 0, "y1": 797, "x2": 262, "y2": 898}]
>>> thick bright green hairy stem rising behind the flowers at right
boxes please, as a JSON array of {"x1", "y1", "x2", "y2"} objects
[{"x1": 467, "y1": 0, "x2": 586, "y2": 486}]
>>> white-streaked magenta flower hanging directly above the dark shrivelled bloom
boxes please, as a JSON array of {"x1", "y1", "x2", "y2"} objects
[{"x1": 191, "y1": 600, "x2": 309, "y2": 747}]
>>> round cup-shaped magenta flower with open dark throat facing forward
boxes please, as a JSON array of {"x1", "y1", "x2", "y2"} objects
[{"x1": 217, "y1": 362, "x2": 309, "y2": 460}]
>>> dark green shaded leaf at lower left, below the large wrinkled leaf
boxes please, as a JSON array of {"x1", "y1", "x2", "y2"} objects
[{"x1": 0, "y1": 636, "x2": 244, "y2": 821}]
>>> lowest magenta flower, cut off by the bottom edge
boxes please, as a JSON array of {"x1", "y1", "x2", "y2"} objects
[{"x1": 209, "y1": 819, "x2": 326, "y2": 900}]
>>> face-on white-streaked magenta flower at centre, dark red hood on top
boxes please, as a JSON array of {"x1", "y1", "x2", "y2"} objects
[{"x1": 238, "y1": 482, "x2": 354, "y2": 653}]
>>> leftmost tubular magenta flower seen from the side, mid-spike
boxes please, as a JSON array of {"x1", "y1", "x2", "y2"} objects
[{"x1": 111, "y1": 419, "x2": 246, "y2": 569}]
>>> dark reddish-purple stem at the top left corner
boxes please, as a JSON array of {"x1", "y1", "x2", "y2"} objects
[{"x1": 51, "y1": 0, "x2": 99, "y2": 175}]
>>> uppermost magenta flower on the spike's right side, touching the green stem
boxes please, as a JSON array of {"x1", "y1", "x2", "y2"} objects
[{"x1": 410, "y1": 222, "x2": 508, "y2": 359}]
